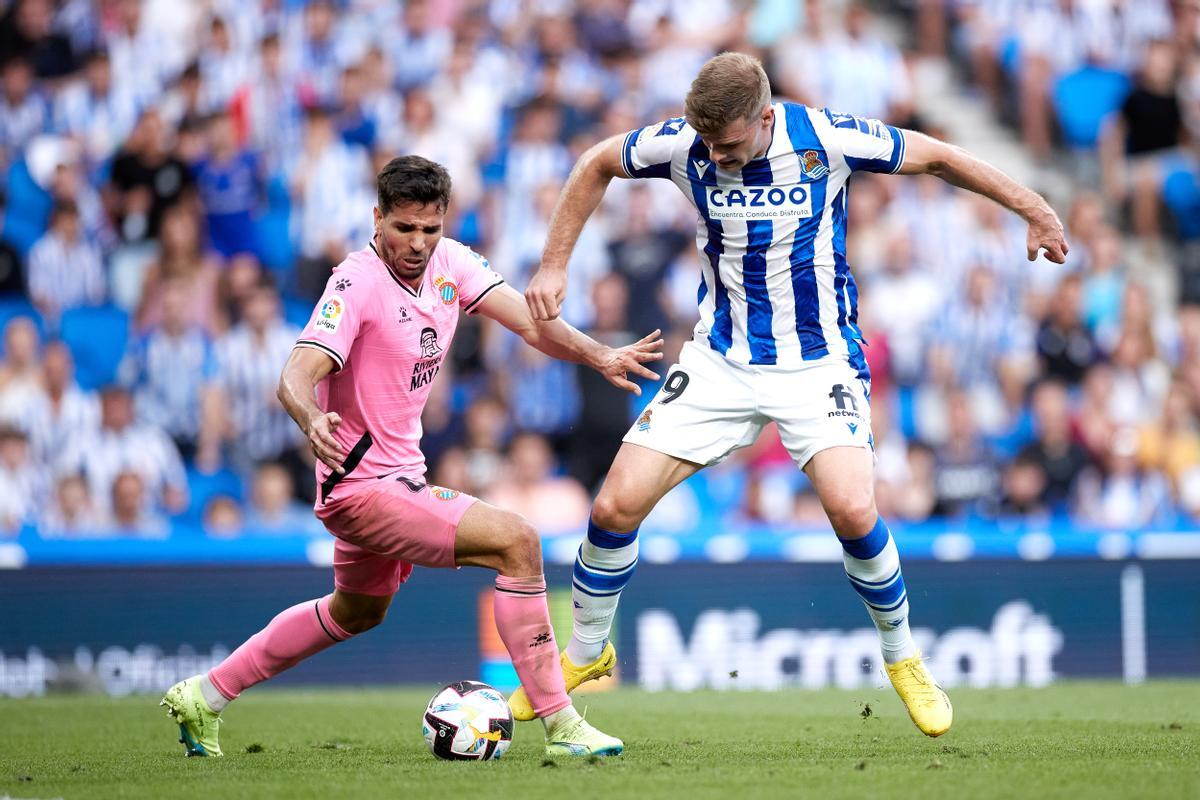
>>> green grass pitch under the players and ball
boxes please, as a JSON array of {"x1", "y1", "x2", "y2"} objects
[{"x1": 0, "y1": 681, "x2": 1200, "y2": 800}]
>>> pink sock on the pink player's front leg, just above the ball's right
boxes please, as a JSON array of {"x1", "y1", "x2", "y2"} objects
[{"x1": 494, "y1": 575, "x2": 571, "y2": 717}]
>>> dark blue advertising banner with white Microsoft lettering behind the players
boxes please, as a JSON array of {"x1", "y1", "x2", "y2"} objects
[{"x1": 0, "y1": 559, "x2": 1200, "y2": 697}]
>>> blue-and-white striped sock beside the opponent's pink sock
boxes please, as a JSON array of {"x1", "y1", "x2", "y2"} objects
[{"x1": 566, "y1": 518, "x2": 637, "y2": 666}]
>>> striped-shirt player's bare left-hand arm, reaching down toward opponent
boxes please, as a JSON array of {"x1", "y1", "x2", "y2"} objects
[{"x1": 526, "y1": 136, "x2": 625, "y2": 320}]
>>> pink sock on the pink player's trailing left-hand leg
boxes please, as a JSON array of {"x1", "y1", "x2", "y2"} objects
[{"x1": 209, "y1": 595, "x2": 353, "y2": 700}]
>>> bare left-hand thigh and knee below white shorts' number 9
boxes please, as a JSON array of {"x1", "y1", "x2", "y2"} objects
[{"x1": 592, "y1": 441, "x2": 703, "y2": 533}]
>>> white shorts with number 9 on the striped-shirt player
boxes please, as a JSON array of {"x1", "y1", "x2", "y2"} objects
[{"x1": 624, "y1": 342, "x2": 874, "y2": 469}]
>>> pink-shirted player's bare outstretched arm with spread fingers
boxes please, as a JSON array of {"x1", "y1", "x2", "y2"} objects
[{"x1": 479, "y1": 284, "x2": 662, "y2": 395}]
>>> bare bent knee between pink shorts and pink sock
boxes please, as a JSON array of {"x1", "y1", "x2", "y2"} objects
[{"x1": 454, "y1": 500, "x2": 541, "y2": 575}]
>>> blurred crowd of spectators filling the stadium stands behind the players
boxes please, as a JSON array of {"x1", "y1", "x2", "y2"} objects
[{"x1": 0, "y1": 0, "x2": 1200, "y2": 537}]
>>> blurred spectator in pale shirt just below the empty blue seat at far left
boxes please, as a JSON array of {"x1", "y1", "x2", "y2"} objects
[{"x1": 56, "y1": 386, "x2": 187, "y2": 513}]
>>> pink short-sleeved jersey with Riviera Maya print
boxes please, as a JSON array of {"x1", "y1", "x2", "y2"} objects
[{"x1": 296, "y1": 239, "x2": 504, "y2": 506}]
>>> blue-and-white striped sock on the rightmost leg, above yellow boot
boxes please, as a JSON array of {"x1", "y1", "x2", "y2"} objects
[{"x1": 838, "y1": 517, "x2": 917, "y2": 664}]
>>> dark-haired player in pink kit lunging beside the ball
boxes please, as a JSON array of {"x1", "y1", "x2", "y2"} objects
[{"x1": 162, "y1": 156, "x2": 662, "y2": 756}]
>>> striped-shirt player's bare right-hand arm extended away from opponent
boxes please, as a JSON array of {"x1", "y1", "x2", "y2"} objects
[{"x1": 899, "y1": 131, "x2": 1069, "y2": 264}]
